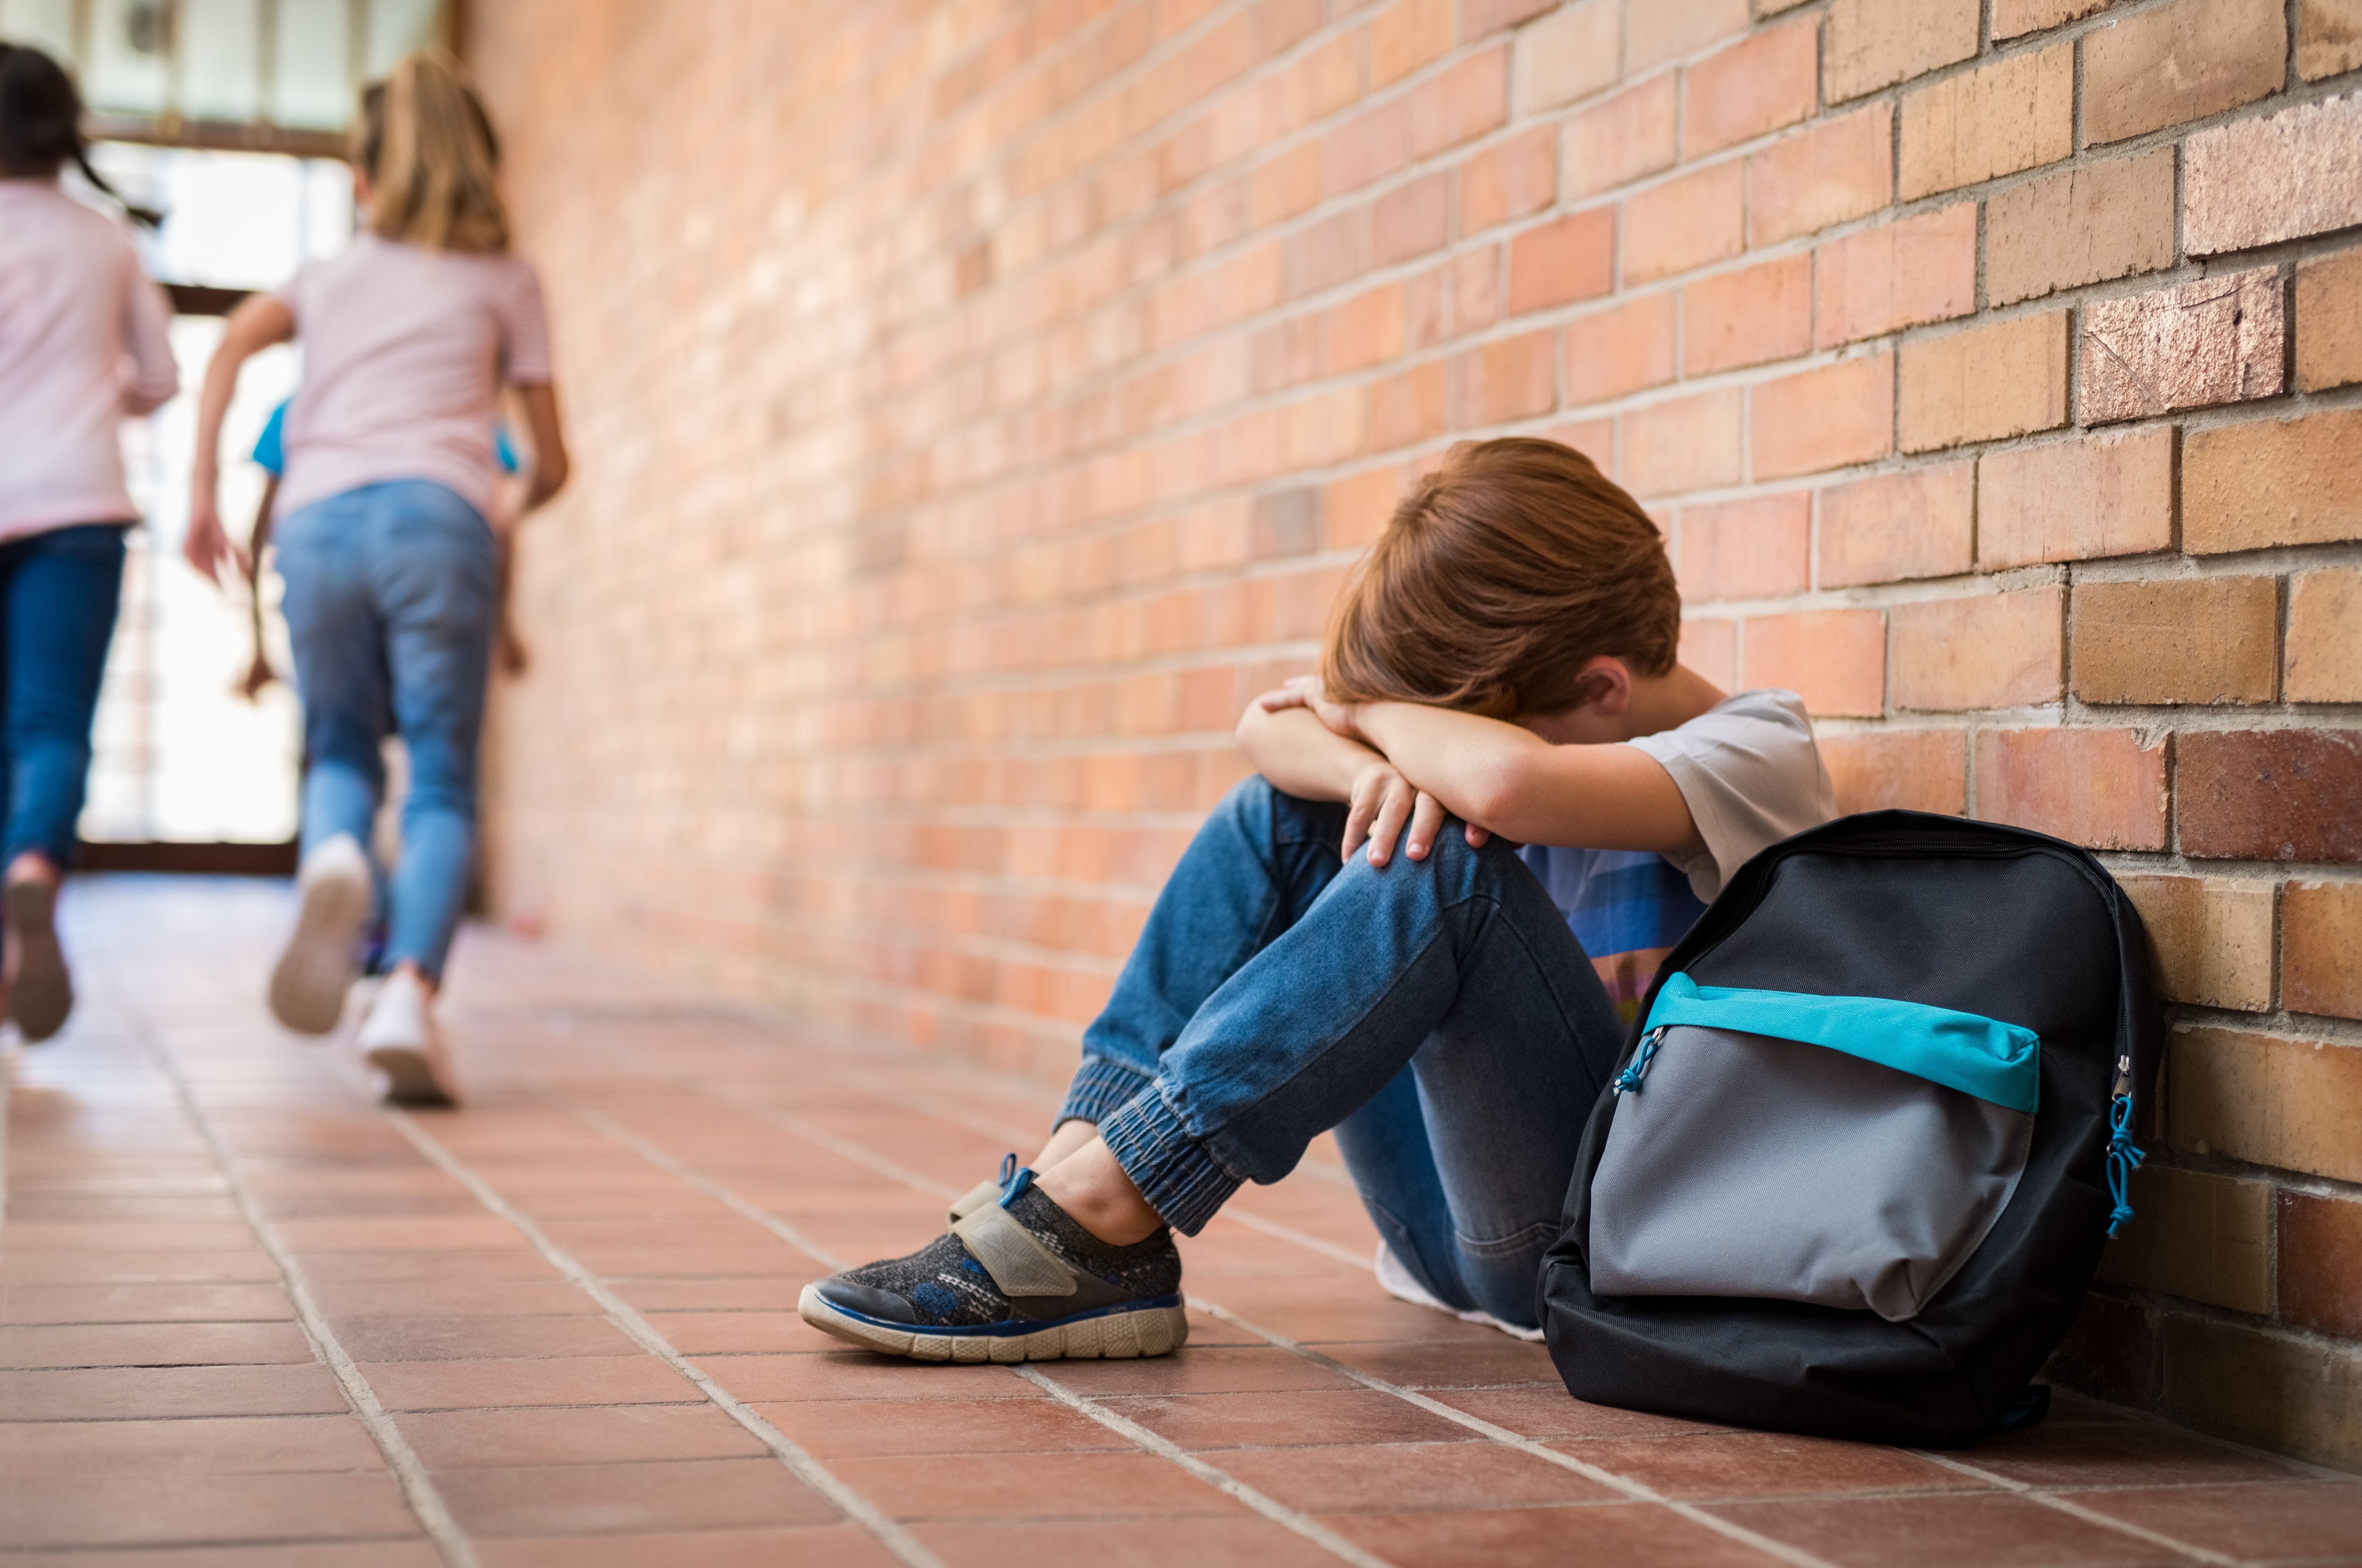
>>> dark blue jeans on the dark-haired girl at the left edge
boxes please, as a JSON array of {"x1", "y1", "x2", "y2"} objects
[{"x1": 0, "y1": 522, "x2": 128, "y2": 869}]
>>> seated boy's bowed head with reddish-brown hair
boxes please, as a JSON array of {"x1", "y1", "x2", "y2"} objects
[{"x1": 1320, "y1": 437, "x2": 1682, "y2": 741}]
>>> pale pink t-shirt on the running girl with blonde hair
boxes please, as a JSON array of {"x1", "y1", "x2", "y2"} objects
[{"x1": 276, "y1": 234, "x2": 550, "y2": 517}]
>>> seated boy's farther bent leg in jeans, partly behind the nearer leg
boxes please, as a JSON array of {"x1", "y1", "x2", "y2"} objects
[{"x1": 1058, "y1": 777, "x2": 1346, "y2": 1122}]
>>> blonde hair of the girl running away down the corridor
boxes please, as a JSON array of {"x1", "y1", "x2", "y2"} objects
[{"x1": 352, "y1": 50, "x2": 508, "y2": 250}]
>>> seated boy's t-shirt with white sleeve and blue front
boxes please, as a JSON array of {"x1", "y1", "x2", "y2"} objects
[{"x1": 1523, "y1": 692, "x2": 1838, "y2": 1018}]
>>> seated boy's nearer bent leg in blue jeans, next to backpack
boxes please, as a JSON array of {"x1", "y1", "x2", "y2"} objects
[{"x1": 1101, "y1": 834, "x2": 1623, "y2": 1322}]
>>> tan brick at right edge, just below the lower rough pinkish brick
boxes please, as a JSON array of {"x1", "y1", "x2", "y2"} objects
[{"x1": 2182, "y1": 409, "x2": 2362, "y2": 555}]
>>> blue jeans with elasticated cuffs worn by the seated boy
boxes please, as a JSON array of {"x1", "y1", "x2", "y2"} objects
[{"x1": 1061, "y1": 779, "x2": 1625, "y2": 1325}]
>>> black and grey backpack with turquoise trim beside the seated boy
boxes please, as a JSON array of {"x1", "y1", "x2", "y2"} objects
[{"x1": 1540, "y1": 810, "x2": 2164, "y2": 1448}]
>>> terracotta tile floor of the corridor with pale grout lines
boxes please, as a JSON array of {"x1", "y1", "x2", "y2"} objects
[{"x1": 0, "y1": 878, "x2": 2362, "y2": 1568}]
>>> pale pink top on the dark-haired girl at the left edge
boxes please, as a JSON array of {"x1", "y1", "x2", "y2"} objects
[{"x1": 0, "y1": 179, "x2": 180, "y2": 541}]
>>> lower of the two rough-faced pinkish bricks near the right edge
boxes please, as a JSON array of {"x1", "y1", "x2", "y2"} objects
[{"x1": 2083, "y1": 267, "x2": 2286, "y2": 425}]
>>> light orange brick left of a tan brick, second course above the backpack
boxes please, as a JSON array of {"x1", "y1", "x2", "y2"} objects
[{"x1": 1887, "y1": 586, "x2": 2067, "y2": 713}]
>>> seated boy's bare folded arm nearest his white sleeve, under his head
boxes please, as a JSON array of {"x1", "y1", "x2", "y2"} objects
[{"x1": 1353, "y1": 701, "x2": 1701, "y2": 855}]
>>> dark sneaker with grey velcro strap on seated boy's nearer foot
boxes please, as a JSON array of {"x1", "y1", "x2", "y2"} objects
[{"x1": 796, "y1": 1171, "x2": 1188, "y2": 1363}]
